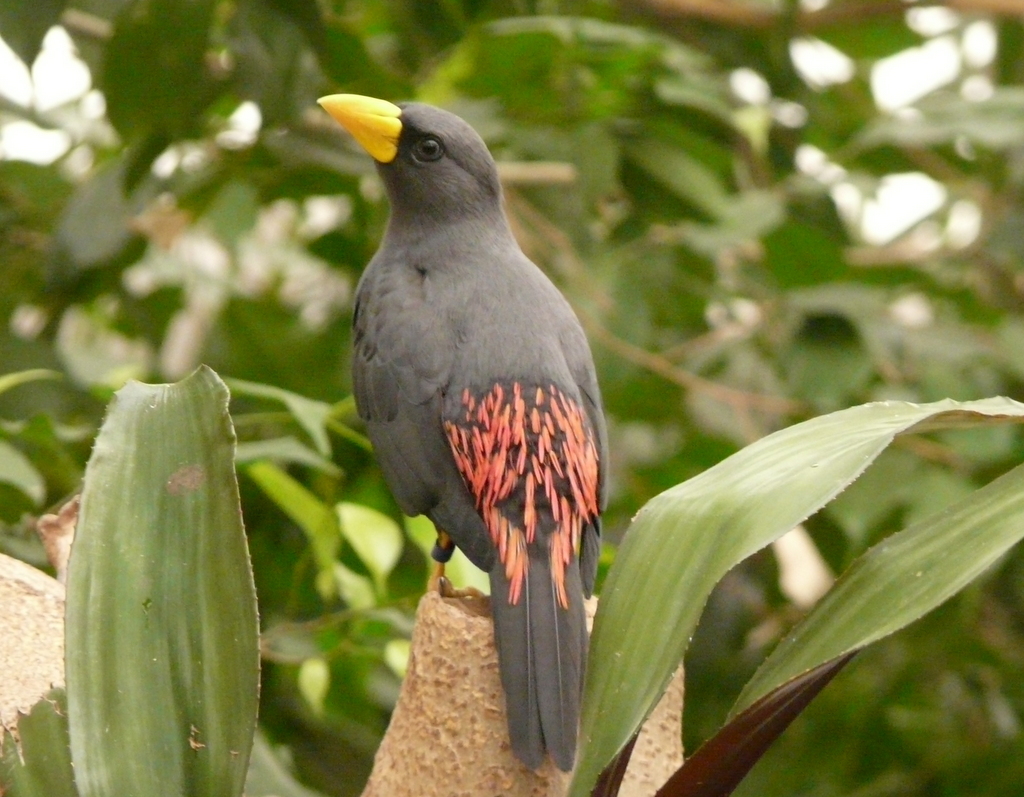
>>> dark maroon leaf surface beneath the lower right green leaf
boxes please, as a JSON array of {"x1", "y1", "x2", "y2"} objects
[{"x1": 655, "y1": 654, "x2": 853, "y2": 797}]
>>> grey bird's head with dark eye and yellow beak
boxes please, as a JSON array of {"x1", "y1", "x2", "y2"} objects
[{"x1": 318, "y1": 94, "x2": 501, "y2": 231}]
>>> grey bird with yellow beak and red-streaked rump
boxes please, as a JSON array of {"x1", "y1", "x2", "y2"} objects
[{"x1": 319, "y1": 94, "x2": 607, "y2": 770}]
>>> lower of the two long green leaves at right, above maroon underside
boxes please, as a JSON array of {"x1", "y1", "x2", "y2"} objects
[{"x1": 733, "y1": 452, "x2": 1024, "y2": 712}]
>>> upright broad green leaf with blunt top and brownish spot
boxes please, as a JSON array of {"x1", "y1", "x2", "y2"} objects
[{"x1": 66, "y1": 367, "x2": 259, "y2": 797}]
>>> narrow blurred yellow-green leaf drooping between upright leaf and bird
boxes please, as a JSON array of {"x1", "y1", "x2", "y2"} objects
[{"x1": 246, "y1": 460, "x2": 341, "y2": 598}]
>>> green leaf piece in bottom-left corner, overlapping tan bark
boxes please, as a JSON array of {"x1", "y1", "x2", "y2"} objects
[{"x1": 0, "y1": 689, "x2": 78, "y2": 797}]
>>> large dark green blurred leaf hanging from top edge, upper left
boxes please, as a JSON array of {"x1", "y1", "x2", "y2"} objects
[{"x1": 99, "y1": 0, "x2": 216, "y2": 140}]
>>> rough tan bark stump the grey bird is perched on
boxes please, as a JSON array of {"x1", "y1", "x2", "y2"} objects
[{"x1": 362, "y1": 592, "x2": 683, "y2": 797}]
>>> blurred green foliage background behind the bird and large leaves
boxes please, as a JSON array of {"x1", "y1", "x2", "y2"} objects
[{"x1": 0, "y1": 0, "x2": 1024, "y2": 797}]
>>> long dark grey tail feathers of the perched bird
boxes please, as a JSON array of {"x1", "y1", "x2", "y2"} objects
[{"x1": 490, "y1": 550, "x2": 587, "y2": 771}]
